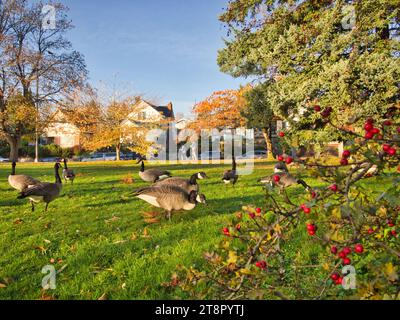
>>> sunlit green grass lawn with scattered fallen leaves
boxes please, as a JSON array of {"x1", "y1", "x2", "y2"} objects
[{"x1": 0, "y1": 161, "x2": 394, "y2": 299}]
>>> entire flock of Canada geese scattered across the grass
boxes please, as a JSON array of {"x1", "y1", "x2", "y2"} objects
[{"x1": 4, "y1": 157, "x2": 311, "y2": 220}]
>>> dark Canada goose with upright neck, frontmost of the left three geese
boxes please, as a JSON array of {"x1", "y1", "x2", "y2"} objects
[{"x1": 18, "y1": 162, "x2": 62, "y2": 211}]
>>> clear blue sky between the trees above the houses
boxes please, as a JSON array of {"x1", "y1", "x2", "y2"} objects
[{"x1": 63, "y1": 0, "x2": 245, "y2": 115}]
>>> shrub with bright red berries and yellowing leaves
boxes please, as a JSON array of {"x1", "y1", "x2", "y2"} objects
[{"x1": 171, "y1": 119, "x2": 400, "y2": 299}]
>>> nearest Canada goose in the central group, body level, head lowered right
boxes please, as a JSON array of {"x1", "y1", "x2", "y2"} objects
[{"x1": 133, "y1": 185, "x2": 206, "y2": 220}]
